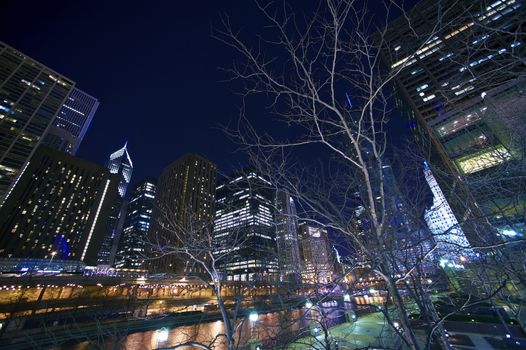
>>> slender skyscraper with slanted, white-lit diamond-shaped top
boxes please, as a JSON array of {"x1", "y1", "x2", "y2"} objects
[{"x1": 97, "y1": 142, "x2": 133, "y2": 265}]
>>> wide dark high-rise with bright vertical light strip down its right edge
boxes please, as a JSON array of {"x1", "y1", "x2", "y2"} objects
[{"x1": 0, "y1": 146, "x2": 119, "y2": 264}]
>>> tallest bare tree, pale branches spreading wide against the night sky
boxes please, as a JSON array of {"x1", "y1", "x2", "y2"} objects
[{"x1": 215, "y1": 1, "x2": 464, "y2": 349}]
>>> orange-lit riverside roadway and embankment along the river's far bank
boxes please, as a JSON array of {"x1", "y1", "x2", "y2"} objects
[{"x1": 0, "y1": 275, "x2": 314, "y2": 349}]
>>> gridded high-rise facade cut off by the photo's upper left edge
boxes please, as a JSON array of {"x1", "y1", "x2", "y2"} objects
[{"x1": 0, "y1": 42, "x2": 75, "y2": 201}]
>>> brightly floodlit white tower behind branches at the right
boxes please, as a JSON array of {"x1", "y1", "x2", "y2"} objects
[{"x1": 424, "y1": 162, "x2": 473, "y2": 264}]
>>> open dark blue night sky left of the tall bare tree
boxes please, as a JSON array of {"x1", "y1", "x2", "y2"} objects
[{"x1": 0, "y1": 0, "x2": 416, "y2": 186}]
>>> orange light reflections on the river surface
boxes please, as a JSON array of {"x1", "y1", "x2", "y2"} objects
[{"x1": 61, "y1": 304, "x2": 339, "y2": 350}]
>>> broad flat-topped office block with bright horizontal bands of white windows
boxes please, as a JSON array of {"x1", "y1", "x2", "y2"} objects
[{"x1": 214, "y1": 171, "x2": 279, "y2": 281}]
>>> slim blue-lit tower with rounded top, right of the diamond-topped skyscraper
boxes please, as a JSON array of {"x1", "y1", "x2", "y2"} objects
[{"x1": 115, "y1": 178, "x2": 157, "y2": 269}]
